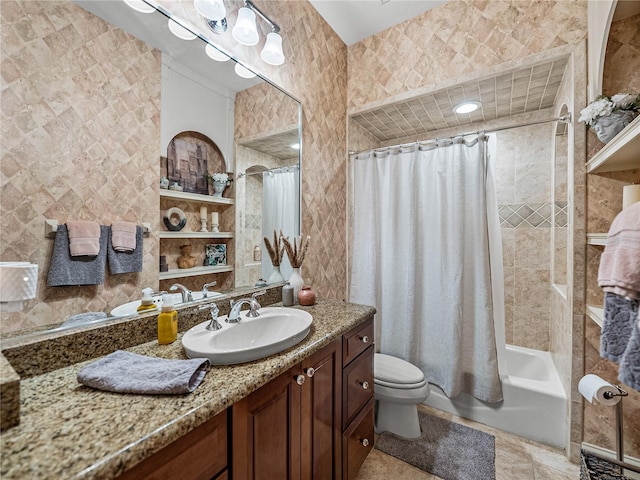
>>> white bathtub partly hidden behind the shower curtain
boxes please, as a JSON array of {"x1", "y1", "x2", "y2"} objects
[{"x1": 424, "y1": 345, "x2": 567, "y2": 448}]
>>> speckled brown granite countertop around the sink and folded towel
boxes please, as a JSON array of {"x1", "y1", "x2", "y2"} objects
[{"x1": 0, "y1": 301, "x2": 375, "y2": 480}]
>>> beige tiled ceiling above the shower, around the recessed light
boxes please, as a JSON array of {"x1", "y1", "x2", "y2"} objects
[{"x1": 351, "y1": 57, "x2": 568, "y2": 142}]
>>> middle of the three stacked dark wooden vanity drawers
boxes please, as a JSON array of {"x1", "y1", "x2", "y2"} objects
[{"x1": 342, "y1": 345, "x2": 373, "y2": 429}]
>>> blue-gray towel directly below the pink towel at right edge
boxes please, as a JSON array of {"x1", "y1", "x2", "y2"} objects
[{"x1": 600, "y1": 292, "x2": 640, "y2": 363}]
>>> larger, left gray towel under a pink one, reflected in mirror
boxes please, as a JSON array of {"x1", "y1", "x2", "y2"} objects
[{"x1": 47, "y1": 225, "x2": 109, "y2": 287}]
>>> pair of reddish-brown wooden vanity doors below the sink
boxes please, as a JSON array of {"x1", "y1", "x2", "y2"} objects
[{"x1": 232, "y1": 339, "x2": 342, "y2": 480}]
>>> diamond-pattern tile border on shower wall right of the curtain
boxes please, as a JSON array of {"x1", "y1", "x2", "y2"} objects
[{"x1": 498, "y1": 202, "x2": 567, "y2": 228}]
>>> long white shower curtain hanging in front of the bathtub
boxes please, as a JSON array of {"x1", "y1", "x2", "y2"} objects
[{"x1": 350, "y1": 135, "x2": 504, "y2": 402}]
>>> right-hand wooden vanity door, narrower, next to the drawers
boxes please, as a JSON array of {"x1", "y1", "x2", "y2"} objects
[{"x1": 302, "y1": 338, "x2": 342, "y2": 480}]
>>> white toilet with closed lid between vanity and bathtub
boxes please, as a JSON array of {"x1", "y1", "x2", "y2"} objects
[{"x1": 373, "y1": 353, "x2": 429, "y2": 438}]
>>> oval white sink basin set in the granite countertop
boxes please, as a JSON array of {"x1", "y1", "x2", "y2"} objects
[{"x1": 182, "y1": 307, "x2": 313, "y2": 365}]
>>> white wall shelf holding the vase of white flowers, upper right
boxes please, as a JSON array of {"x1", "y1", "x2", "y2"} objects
[{"x1": 587, "y1": 115, "x2": 640, "y2": 173}]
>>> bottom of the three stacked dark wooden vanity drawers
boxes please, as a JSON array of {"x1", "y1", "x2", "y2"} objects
[{"x1": 342, "y1": 398, "x2": 375, "y2": 480}]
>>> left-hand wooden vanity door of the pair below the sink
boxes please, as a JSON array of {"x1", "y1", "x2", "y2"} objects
[{"x1": 231, "y1": 367, "x2": 304, "y2": 480}]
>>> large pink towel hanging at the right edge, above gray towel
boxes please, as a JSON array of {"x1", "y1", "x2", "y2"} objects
[{"x1": 598, "y1": 202, "x2": 640, "y2": 300}]
